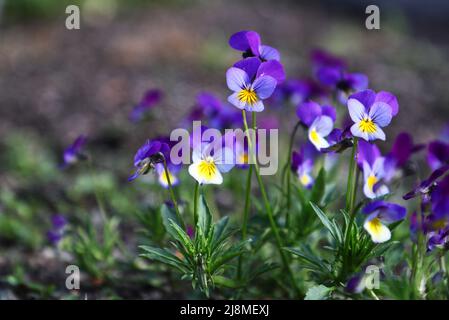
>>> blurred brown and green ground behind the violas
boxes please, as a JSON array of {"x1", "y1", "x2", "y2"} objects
[{"x1": 0, "y1": 0, "x2": 449, "y2": 298}]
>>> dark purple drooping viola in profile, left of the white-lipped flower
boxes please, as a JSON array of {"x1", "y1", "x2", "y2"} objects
[{"x1": 128, "y1": 140, "x2": 170, "y2": 181}]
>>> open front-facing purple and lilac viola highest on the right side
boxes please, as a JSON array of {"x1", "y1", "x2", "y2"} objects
[{"x1": 348, "y1": 90, "x2": 399, "y2": 141}]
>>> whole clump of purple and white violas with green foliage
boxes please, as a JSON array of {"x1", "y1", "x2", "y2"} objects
[{"x1": 54, "y1": 31, "x2": 449, "y2": 299}]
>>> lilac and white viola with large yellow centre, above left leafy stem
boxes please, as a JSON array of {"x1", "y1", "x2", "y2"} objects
[{"x1": 189, "y1": 143, "x2": 235, "y2": 184}]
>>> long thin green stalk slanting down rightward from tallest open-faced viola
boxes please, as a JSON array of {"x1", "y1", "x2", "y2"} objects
[{"x1": 242, "y1": 110, "x2": 300, "y2": 294}]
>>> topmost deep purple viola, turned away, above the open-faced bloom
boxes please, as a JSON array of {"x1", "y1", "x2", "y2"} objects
[{"x1": 229, "y1": 30, "x2": 281, "y2": 61}]
